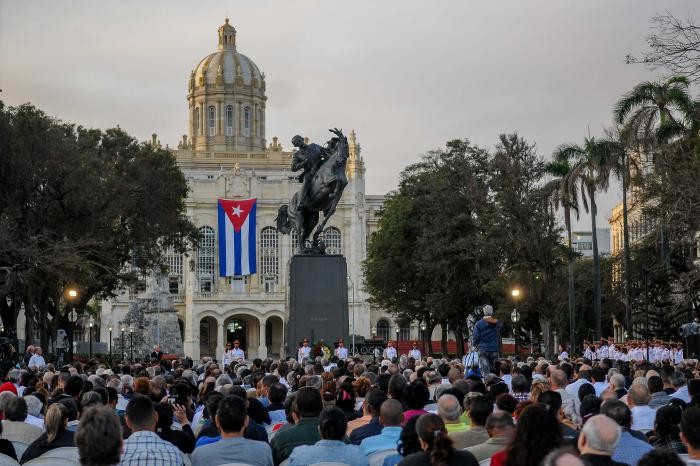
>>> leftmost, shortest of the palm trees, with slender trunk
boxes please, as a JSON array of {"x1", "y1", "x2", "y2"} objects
[{"x1": 545, "y1": 156, "x2": 579, "y2": 352}]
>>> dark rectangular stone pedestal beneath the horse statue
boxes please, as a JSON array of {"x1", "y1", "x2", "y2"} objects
[{"x1": 287, "y1": 255, "x2": 349, "y2": 358}]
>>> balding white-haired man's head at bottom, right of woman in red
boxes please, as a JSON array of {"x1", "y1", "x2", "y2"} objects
[{"x1": 578, "y1": 414, "x2": 626, "y2": 466}]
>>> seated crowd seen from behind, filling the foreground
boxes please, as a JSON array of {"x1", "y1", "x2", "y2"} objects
[{"x1": 0, "y1": 342, "x2": 700, "y2": 466}]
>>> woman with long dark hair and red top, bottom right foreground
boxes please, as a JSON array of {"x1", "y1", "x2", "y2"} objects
[{"x1": 491, "y1": 403, "x2": 563, "y2": 466}]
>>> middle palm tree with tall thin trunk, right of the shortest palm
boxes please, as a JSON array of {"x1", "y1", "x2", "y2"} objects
[{"x1": 554, "y1": 137, "x2": 615, "y2": 339}]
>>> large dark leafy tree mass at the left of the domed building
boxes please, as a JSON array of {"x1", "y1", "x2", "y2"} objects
[{"x1": 0, "y1": 103, "x2": 197, "y2": 345}]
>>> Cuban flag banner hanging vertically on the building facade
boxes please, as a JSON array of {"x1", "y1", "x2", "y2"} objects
[{"x1": 218, "y1": 199, "x2": 257, "y2": 277}]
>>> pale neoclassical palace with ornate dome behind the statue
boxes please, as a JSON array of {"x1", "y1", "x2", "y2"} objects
[{"x1": 99, "y1": 19, "x2": 400, "y2": 358}]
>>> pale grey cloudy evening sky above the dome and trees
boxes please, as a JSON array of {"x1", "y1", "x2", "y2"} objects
[{"x1": 0, "y1": 0, "x2": 700, "y2": 229}]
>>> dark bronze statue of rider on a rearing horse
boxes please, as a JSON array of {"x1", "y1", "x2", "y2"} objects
[{"x1": 277, "y1": 128, "x2": 349, "y2": 254}]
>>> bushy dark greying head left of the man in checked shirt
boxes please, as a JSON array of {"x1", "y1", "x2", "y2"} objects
[{"x1": 75, "y1": 406, "x2": 122, "y2": 466}]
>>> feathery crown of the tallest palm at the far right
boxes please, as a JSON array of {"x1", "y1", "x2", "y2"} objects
[{"x1": 613, "y1": 76, "x2": 694, "y2": 147}]
